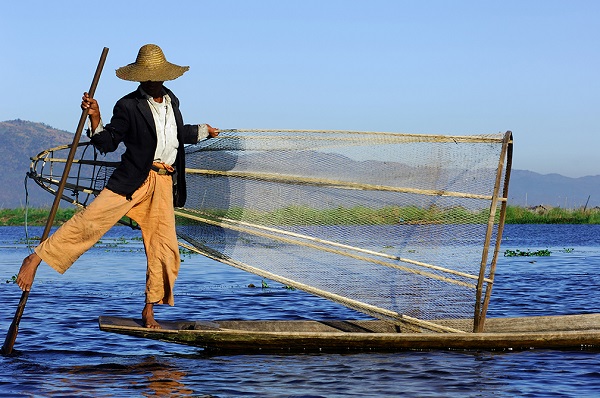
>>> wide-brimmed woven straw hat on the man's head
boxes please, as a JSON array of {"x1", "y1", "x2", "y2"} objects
[{"x1": 116, "y1": 44, "x2": 190, "y2": 82}]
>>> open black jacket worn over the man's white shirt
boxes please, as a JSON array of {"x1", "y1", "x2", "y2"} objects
[{"x1": 91, "y1": 88, "x2": 198, "y2": 207}]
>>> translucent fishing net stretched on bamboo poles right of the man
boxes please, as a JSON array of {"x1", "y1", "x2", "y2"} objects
[{"x1": 176, "y1": 130, "x2": 510, "y2": 331}]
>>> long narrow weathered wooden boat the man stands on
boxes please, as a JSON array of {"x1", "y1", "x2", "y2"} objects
[{"x1": 99, "y1": 314, "x2": 600, "y2": 353}]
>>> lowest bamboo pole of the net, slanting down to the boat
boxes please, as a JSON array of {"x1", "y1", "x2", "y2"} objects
[{"x1": 180, "y1": 238, "x2": 465, "y2": 333}]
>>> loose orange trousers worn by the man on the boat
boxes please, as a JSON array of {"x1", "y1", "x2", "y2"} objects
[{"x1": 35, "y1": 163, "x2": 180, "y2": 305}]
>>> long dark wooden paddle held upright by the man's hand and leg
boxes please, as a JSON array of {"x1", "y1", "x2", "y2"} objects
[{"x1": 2, "y1": 47, "x2": 108, "y2": 355}]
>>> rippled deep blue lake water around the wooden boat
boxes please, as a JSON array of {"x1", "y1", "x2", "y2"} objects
[{"x1": 0, "y1": 225, "x2": 600, "y2": 397}]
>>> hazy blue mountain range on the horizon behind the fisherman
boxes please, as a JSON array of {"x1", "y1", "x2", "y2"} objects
[{"x1": 0, "y1": 119, "x2": 600, "y2": 209}]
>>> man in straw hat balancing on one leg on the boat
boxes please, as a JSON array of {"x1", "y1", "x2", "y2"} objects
[{"x1": 17, "y1": 44, "x2": 219, "y2": 328}]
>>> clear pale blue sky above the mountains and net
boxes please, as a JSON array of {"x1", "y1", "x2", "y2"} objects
[{"x1": 0, "y1": 0, "x2": 600, "y2": 177}]
